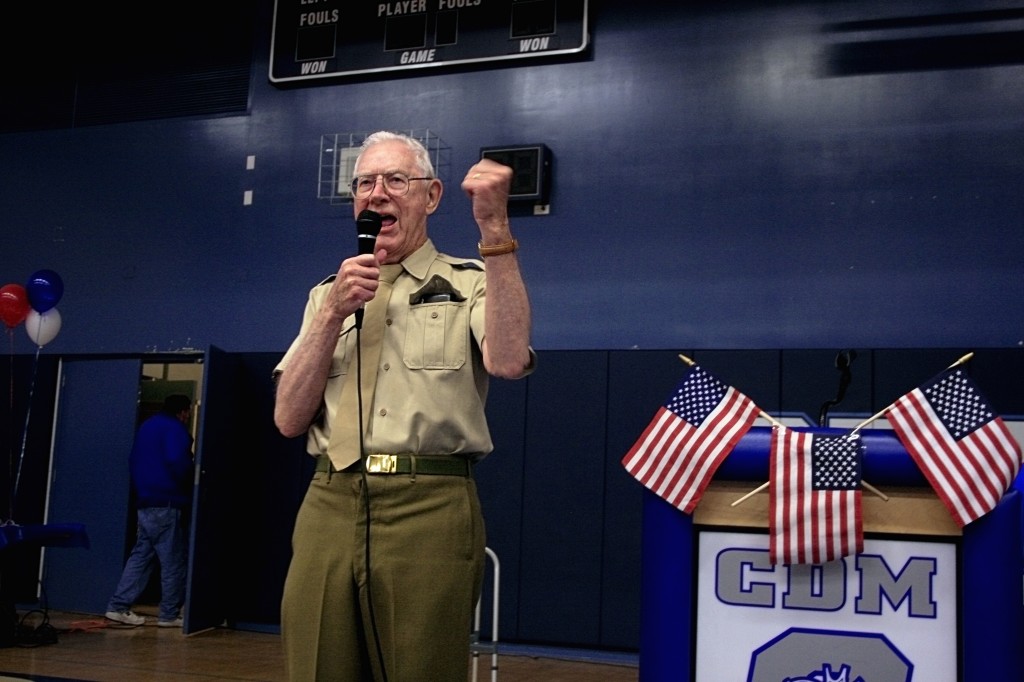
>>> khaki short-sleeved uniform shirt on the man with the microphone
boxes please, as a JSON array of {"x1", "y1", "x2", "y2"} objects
[{"x1": 275, "y1": 240, "x2": 516, "y2": 460}]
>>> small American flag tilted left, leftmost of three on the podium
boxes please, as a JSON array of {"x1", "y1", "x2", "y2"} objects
[{"x1": 623, "y1": 365, "x2": 761, "y2": 514}]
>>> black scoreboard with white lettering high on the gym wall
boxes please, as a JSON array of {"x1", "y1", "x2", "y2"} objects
[{"x1": 270, "y1": 0, "x2": 589, "y2": 83}]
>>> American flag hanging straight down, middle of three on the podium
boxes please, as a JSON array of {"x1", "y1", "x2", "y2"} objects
[{"x1": 768, "y1": 426, "x2": 864, "y2": 564}]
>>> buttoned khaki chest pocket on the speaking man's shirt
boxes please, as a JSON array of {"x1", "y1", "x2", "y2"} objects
[{"x1": 403, "y1": 301, "x2": 469, "y2": 370}]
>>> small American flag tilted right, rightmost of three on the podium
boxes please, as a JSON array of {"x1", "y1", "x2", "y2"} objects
[{"x1": 886, "y1": 368, "x2": 1021, "y2": 527}]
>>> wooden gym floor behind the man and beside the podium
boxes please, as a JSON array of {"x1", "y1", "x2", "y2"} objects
[{"x1": 0, "y1": 609, "x2": 638, "y2": 682}]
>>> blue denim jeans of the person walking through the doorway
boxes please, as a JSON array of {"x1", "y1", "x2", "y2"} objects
[{"x1": 106, "y1": 507, "x2": 188, "y2": 621}]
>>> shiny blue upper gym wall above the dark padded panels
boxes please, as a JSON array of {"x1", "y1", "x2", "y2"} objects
[{"x1": 0, "y1": 0, "x2": 1024, "y2": 353}]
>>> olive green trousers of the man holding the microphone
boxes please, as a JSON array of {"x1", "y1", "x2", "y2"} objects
[{"x1": 282, "y1": 472, "x2": 485, "y2": 682}]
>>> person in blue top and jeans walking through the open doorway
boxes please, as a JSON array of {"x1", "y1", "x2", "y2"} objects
[{"x1": 105, "y1": 395, "x2": 195, "y2": 628}]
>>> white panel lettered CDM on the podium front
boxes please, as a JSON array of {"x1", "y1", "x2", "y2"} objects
[{"x1": 693, "y1": 526, "x2": 954, "y2": 682}]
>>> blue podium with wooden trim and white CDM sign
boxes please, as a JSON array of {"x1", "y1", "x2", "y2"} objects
[{"x1": 640, "y1": 427, "x2": 1024, "y2": 682}]
